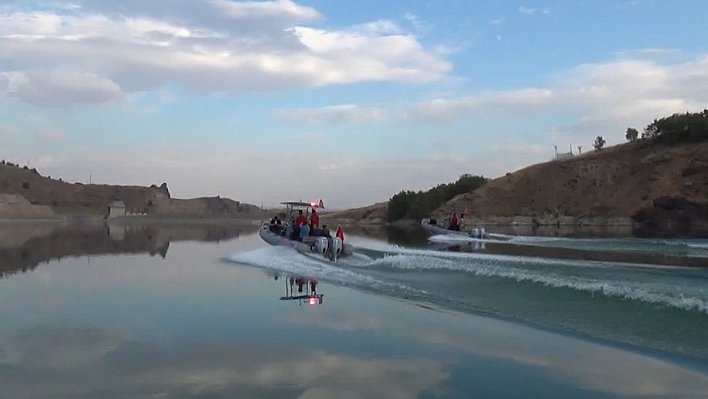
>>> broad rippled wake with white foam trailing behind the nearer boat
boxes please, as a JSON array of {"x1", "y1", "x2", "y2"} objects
[{"x1": 228, "y1": 237, "x2": 708, "y2": 358}]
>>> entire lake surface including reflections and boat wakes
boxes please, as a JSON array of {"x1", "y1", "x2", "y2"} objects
[{"x1": 0, "y1": 225, "x2": 708, "y2": 399}]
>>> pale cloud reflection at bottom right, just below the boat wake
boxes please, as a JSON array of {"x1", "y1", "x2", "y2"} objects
[{"x1": 287, "y1": 313, "x2": 708, "y2": 397}]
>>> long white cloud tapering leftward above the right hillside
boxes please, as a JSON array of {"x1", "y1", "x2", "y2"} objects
[{"x1": 280, "y1": 52, "x2": 708, "y2": 144}]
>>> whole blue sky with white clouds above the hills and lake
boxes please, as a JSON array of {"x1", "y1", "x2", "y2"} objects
[{"x1": 0, "y1": 0, "x2": 708, "y2": 209}]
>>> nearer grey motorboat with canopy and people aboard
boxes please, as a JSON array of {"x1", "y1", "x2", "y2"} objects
[{"x1": 258, "y1": 201, "x2": 354, "y2": 262}]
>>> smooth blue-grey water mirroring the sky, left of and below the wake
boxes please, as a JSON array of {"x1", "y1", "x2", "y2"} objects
[{"x1": 0, "y1": 226, "x2": 708, "y2": 399}]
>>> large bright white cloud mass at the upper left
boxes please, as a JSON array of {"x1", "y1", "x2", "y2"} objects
[{"x1": 0, "y1": 0, "x2": 451, "y2": 105}]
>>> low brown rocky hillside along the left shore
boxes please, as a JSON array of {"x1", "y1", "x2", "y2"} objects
[{"x1": 0, "y1": 164, "x2": 260, "y2": 218}]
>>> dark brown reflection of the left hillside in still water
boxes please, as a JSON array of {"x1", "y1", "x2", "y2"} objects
[{"x1": 0, "y1": 223, "x2": 257, "y2": 278}]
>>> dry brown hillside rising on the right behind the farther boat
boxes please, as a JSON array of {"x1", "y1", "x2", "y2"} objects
[{"x1": 436, "y1": 141, "x2": 708, "y2": 233}]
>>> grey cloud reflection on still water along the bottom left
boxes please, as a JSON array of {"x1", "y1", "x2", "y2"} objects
[{"x1": 0, "y1": 326, "x2": 448, "y2": 399}]
